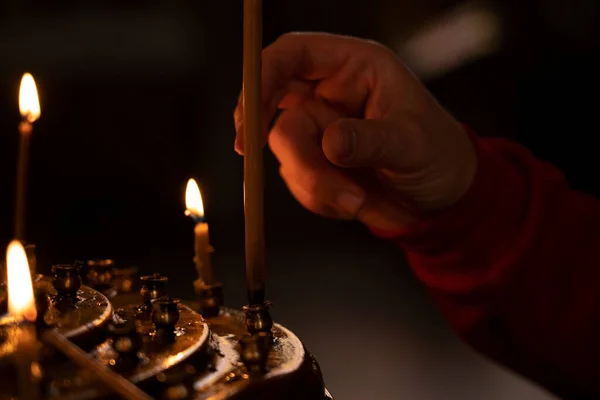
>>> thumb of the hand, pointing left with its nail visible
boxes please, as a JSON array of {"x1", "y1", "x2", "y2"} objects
[{"x1": 322, "y1": 119, "x2": 408, "y2": 170}]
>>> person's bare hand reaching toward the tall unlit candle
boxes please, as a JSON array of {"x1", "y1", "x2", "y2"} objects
[{"x1": 234, "y1": 33, "x2": 477, "y2": 230}]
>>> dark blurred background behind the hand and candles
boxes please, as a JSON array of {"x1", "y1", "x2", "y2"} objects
[{"x1": 0, "y1": 0, "x2": 600, "y2": 400}]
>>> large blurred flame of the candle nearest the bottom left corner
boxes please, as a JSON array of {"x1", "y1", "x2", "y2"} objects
[{"x1": 6, "y1": 240, "x2": 37, "y2": 321}]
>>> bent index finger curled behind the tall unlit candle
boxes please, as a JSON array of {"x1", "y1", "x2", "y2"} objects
[{"x1": 235, "y1": 33, "x2": 387, "y2": 148}]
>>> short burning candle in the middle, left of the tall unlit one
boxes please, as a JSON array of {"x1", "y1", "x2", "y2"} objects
[{"x1": 185, "y1": 179, "x2": 214, "y2": 285}]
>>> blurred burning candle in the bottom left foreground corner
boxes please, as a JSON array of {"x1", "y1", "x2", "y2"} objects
[{"x1": 6, "y1": 240, "x2": 41, "y2": 399}]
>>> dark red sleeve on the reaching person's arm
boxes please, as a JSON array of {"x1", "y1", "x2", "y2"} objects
[{"x1": 376, "y1": 133, "x2": 600, "y2": 399}]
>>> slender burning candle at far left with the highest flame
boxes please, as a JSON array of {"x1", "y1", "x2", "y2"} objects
[{"x1": 15, "y1": 73, "x2": 41, "y2": 239}]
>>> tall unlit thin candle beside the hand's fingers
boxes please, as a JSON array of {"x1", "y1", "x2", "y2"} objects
[{"x1": 243, "y1": 0, "x2": 266, "y2": 305}]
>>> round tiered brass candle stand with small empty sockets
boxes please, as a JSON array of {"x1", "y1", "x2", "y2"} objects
[{"x1": 0, "y1": 255, "x2": 329, "y2": 400}]
